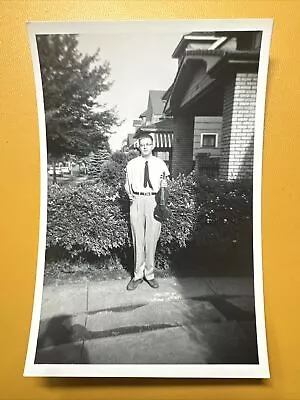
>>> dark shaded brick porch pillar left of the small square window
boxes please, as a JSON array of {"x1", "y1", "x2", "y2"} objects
[{"x1": 171, "y1": 116, "x2": 194, "y2": 177}]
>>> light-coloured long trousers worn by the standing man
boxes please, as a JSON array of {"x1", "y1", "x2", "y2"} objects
[{"x1": 130, "y1": 195, "x2": 161, "y2": 280}]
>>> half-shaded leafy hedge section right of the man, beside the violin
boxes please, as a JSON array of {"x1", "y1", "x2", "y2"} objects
[{"x1": 158, "y1": 172, "x2": 252, "y2": 265}]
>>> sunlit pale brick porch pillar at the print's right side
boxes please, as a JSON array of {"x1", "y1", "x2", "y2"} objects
[{"x1": 220, "y1": 73, "x2": 257, "y2": 180}]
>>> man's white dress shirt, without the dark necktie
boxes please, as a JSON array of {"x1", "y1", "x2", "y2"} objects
[{"x1": 125, "y1": 156, "x2": 170, "y2": 198}]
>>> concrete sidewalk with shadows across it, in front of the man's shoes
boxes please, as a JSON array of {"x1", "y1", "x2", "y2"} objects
[{"x1": 36, "y1": 278, "x2": 257, "y2": 364}]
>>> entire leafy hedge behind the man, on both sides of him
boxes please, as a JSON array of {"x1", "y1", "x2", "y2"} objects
[{"x1": 47, "y1": 162, "x2": 252, "y2": 268}]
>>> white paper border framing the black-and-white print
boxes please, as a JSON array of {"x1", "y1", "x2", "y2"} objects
[{"x1": 23, "y1": 19, "x2": 273, "y2": 378}]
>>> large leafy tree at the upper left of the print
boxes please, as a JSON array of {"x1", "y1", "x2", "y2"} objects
[{"x1": 37, "y1": 35, "x2": 120, "y2": 181}]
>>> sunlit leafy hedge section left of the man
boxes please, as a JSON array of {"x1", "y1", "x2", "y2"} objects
[{"x1": 47, "y1": 183, "x2": 129, "y2": 257}]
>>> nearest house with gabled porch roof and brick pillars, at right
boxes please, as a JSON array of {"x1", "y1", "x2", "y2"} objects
[{"x1": 163, "y1": 31, "x2": 261, "y2": 180}]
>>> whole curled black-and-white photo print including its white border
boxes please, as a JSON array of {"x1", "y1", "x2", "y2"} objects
[{"x1": 24, "y1": 19, "x2": 272, "y2": 378}]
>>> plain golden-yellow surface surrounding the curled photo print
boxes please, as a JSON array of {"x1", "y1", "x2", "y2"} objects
[{"x1": 0, "y1": 0, "x2": 300, "y2": 400}]
